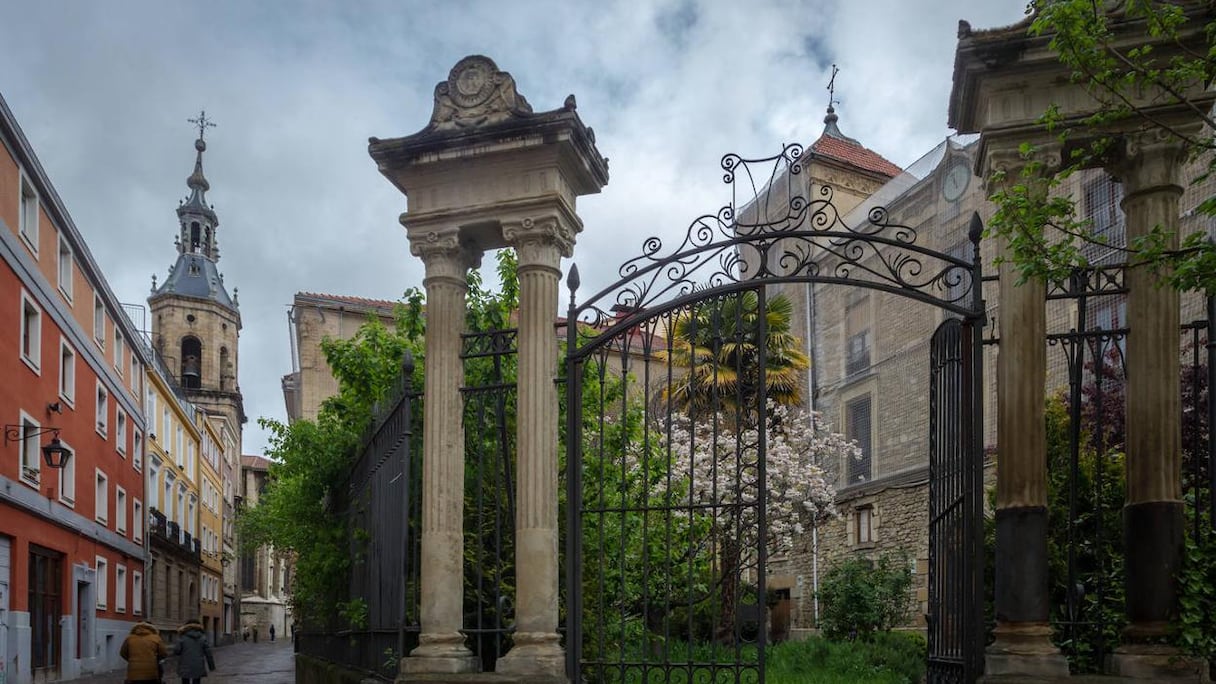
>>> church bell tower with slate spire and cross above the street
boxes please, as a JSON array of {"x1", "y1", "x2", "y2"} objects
[{"x1": 148, "y1": 112, "x2": 246, "y2": 434}]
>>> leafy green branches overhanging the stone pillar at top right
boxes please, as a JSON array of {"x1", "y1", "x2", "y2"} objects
[{"x1": 986, "y1": 0, "x2": 1216, "y2": 292}]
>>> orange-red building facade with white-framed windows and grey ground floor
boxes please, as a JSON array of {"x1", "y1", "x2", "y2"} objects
[{"x1": 0, "y1": 97, "x2": 148, "y2": 684}]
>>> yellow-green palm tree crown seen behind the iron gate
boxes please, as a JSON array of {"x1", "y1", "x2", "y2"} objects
[{"x1": 658, "y1": 291, "x2": 810, "y2": 415}]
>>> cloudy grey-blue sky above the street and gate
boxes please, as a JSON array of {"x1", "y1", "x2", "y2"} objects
[{"x1": 0, "y1": 0, "x2": 1025, "y2": 453}]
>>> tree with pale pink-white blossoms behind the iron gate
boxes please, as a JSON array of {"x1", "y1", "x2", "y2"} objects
[{"x1": 652, "y1": 402, "x2": 861, "y2": 640}]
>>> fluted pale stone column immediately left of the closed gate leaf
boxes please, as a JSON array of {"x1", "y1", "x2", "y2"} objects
[{"x1": 496, "y1": 215, "x2": 576, "y2": 682}]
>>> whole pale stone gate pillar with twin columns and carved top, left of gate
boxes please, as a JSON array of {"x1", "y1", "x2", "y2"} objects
[{"x1": 368, "y1": 55, "x2": 608, "y2": 683}]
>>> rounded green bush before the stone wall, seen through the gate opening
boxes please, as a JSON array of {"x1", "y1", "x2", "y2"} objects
[{"x1": 820, "y1": 554, "x2": 912, "y2": 640}]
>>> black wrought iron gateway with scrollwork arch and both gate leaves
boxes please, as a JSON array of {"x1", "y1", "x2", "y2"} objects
[{"x1": 564, "y1": 145, "x2": 984, "y2": 683}]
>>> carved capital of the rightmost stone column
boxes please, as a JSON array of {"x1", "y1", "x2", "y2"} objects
[{"x1": 1105, "y1": 124, "x2": 1200, "y2": 197}]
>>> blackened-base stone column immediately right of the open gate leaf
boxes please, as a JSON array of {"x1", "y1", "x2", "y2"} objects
[{"x1": 984, "y1": 148, "x2": 1068, "y2": 677}]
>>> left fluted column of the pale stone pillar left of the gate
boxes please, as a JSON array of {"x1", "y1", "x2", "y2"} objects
[{"x1": 401, "y1": 230, "x2": 480, "y2": 674}]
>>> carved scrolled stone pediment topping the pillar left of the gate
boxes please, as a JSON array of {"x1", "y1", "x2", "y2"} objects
[{"x1": 427, "y1": 55, "x2": 533, "y2": 130}]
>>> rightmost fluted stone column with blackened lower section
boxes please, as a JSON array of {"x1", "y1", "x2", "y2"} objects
[{"x1": 1111, "y1": 131, "x2": 1186, "y2": 675}]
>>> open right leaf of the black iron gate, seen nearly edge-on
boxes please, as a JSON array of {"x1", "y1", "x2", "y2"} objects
[{"x1": 927, "y1": 319, "x2": 984, "y2": 684}]
